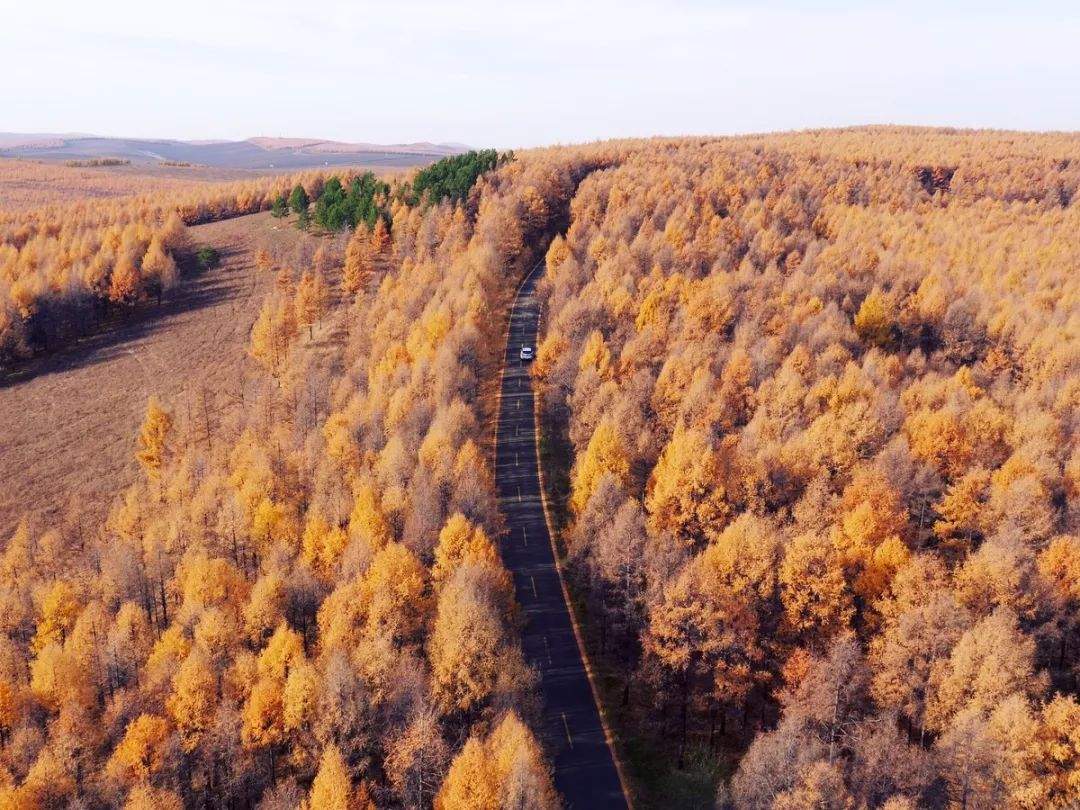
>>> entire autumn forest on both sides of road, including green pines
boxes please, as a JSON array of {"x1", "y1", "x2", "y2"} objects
[{"x1": 0, "y1": 127, "x2": 1080, "y2": 810}]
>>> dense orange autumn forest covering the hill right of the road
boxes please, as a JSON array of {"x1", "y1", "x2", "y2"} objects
[{"x1": 535, "y1": 129, "x2": 1080, "y2": 810}]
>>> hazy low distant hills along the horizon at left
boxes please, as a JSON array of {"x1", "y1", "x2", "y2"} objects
[{"x1": 0, "y1": 133, "x2": 468, "y2": 168}]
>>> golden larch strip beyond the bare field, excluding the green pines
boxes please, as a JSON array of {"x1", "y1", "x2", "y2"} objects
[{"x1": 0, "y1": 173, "x2": 368, "y2": 369}]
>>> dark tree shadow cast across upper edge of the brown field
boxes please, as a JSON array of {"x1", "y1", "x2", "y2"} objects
[{"x1": 0, "y1": 248, "x2": 251, "y2": 391}]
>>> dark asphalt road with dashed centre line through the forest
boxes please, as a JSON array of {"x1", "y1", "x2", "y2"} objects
[{"x1": 496, "y1": 264, "x2": 626, "y2": 810}]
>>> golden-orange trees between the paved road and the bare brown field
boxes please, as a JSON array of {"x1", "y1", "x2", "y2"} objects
[{"x1": 0, "y1": 142, "x2": 610, "y2": 810}]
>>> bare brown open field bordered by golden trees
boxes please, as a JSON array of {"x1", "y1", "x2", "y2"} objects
[{"x1": 0, "y1": 214, "x2": 305, "y2": 540}]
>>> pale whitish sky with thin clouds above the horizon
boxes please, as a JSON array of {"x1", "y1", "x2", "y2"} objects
[{"x1": 0, "y1": 0, "x2": 1080, "y2": 148}]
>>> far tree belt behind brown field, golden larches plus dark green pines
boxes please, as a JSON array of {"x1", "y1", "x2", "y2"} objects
[{"x1": 0, "y1": 151, "x2": 520, "y2": 370}]
